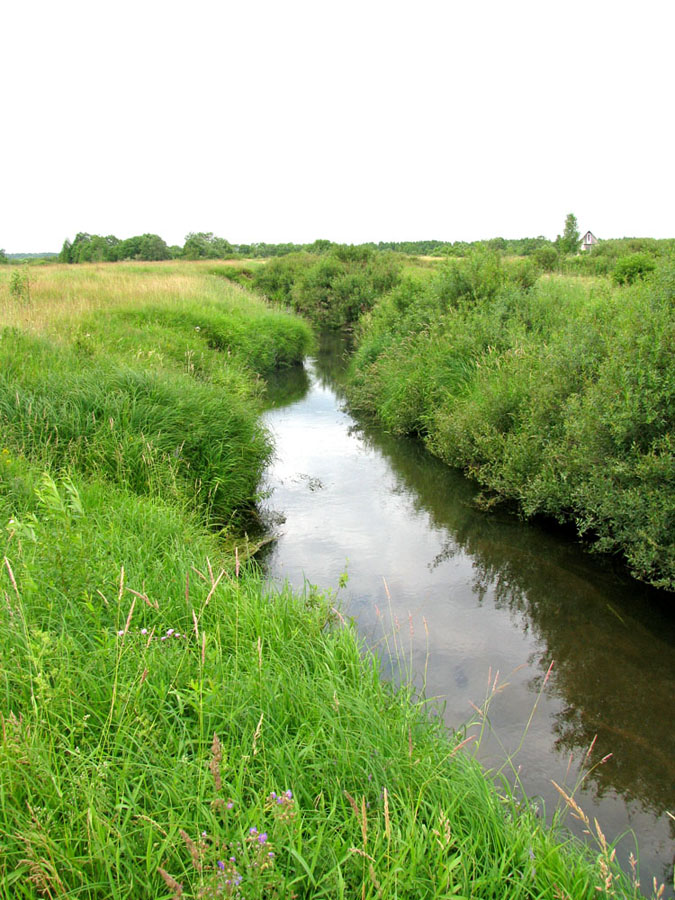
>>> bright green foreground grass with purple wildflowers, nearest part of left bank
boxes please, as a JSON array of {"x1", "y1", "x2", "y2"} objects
[{"x1": 0, "y1": 454, "x2": 648, "y2": 900}]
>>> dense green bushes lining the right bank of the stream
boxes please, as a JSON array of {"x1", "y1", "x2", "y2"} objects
[{"x1": 349, "y1": 254, "x2": 675, "y2": 590}]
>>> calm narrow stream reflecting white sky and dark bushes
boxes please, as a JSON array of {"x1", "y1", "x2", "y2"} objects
[{"x1": 265, "y1": 330, "x2": 675, "y2": 896}]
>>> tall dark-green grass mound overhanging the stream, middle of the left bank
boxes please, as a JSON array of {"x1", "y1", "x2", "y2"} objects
[{"x1": 0, "y1": 331, "x2": 271, "y2": 524}]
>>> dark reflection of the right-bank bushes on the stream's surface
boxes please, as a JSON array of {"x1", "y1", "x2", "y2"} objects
[{"x1": 360, "y1": 427, "x2": 675, "y2": 814}]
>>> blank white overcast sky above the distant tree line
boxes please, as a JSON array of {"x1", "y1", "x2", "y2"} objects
[{"x1": 0, "y1": 0, "x2": 675, "y2": 252}]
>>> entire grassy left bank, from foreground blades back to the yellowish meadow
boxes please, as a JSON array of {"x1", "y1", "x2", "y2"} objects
[{"x1": 0, "y1": 258, "x2": 656, "y2": 900}]
